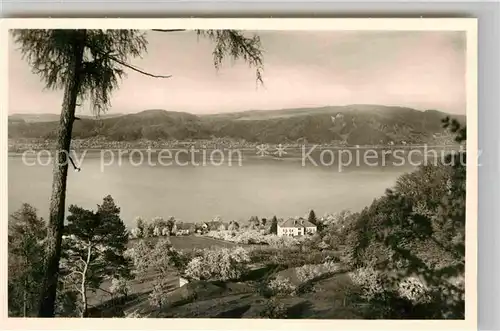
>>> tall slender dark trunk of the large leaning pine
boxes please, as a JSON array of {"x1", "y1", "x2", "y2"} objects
[{"x1": 38, "y1": 30, "x2": 86, "y2": 317}]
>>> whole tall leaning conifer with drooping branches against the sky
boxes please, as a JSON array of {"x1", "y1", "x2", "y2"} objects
[{"x1": 12, "y1": 29, "x2": 262, "y2": 317}]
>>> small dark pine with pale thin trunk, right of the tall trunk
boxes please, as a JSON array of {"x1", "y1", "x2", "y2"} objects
[{"x1": 62, "y1": 196, "x2": 131, "y2": 317}]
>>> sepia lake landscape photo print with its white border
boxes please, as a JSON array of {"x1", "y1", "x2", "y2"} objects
[{"x1": 3, "y1": 19, "x2": 478, "y2": 323}]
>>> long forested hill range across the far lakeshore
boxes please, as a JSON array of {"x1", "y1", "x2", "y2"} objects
[{"x1": 8, "y1": 105, "x2": 465, "y2": 145}]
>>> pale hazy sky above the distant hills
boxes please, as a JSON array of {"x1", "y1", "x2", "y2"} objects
[{"x1": 9, "y1": 31, "x2": 465, "y2": 114}]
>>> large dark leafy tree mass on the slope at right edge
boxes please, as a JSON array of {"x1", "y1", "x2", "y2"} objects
[{"x1": 346, "y1": 121, "x2": 466, "y2": 319}]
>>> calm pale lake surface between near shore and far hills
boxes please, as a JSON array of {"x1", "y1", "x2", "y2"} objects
[{"x1": 8, "y1": 155, "x2": 413, "y2": 226}]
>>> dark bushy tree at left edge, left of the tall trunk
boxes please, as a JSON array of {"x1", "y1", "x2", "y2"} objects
[{"x1": 8, "y1": 203, "x2": 46, "y2": 317}]
